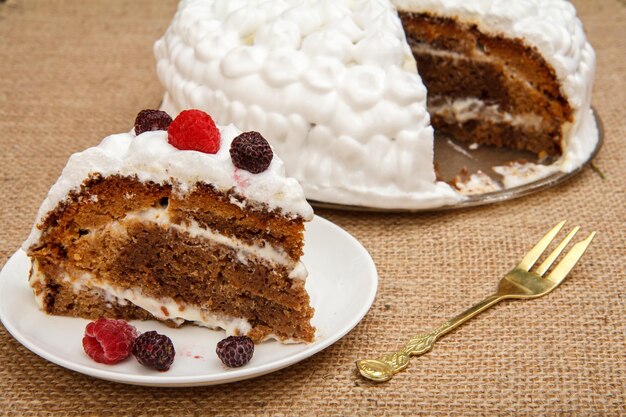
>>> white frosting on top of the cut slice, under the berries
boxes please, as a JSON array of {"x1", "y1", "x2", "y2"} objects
[{"x1": 22, "y1": 125, "x2": 313, "y2": 250}]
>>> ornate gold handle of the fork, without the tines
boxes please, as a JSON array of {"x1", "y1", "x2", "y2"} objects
[{"x1": 356, "y1": 295, "x2": 505, "y2": 382}]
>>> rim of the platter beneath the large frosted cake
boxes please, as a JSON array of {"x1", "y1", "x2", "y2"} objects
[{"x1": 307, "y1": 107, "x2": 604, "y2": 213}]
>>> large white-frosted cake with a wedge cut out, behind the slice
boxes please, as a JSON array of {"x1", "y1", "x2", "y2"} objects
[{"x1": 154, "y1": 0, "x2": 598, "y2": 208}]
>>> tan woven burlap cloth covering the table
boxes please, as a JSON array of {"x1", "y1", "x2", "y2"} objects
[{"x1": 0, "y1": 0, "x2": 626, "y2": 417}]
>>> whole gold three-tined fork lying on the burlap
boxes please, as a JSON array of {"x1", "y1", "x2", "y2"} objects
[{"x1": 356, "y1": 220, "x2": 596, "y2": 382}]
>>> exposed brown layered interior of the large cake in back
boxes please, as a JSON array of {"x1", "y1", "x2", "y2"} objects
[{"x1": 399, "y1": 11, "x2": 572, "y2": 156}]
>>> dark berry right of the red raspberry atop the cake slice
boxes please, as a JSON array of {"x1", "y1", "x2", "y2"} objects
[{"x1": 230, "y1": 132, "x2": 274, "y2": 174}]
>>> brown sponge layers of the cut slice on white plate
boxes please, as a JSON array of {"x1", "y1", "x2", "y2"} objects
[{"x1": 29, "y1": 176, "x2": 314, "y2": 341}]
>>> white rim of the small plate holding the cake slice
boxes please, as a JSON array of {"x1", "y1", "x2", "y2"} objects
[{"x1": 0, "y1": 215, "x2": 379, "y2": 387}]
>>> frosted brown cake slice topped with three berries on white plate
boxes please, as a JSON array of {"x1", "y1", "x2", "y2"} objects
[{"x1": 23, "y1": 110, "x2": 314, "y2": 342}]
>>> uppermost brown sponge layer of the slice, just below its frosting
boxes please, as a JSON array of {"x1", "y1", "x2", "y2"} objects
[{"x1": 29, "y1": 175, "x2": 304, "y2": 262}]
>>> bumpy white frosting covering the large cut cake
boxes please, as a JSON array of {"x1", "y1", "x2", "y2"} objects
[{"x1": 154, "y1": 0, "x2": 598, "y2": 209}]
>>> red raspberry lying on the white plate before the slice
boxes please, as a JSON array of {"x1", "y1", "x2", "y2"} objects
[{"x1": 83, "y1": 318, "x2": 139, "y2": 365}]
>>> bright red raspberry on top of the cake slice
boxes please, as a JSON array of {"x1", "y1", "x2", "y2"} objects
[{"x1": 167, "y1": 110, "x2": 220, "y2": 153}]
